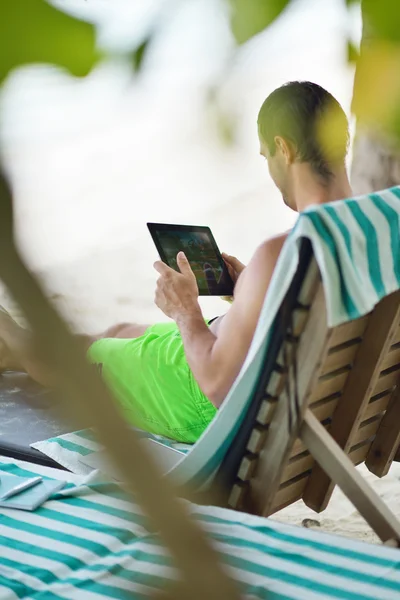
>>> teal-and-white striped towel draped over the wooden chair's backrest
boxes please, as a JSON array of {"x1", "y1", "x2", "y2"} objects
[{"x1": 32, "y1": 186, "x2": 400, "y2": 489}]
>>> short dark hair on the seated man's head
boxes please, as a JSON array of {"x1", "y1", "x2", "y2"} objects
[{"x1": 258, "y1": 81, "x2": 349, "y2": 179}]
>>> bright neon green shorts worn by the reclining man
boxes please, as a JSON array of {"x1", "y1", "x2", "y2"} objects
[{"x1": 87, "y1": 323, "x2": 216, "y2": 443}]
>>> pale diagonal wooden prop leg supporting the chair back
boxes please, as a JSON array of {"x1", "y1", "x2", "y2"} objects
[{"x1": 300, "y1": 410, "x2": 400, "y2": 542}]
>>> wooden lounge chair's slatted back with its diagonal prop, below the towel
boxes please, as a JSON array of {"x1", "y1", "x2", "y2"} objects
[{"x1": 225, "y1": 238, "x2": 400, "y2": 542}]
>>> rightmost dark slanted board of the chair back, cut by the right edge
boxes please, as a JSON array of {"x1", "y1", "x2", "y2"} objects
[{"x1": 365, "y1": 386, "x2": 400, "y2": 477}]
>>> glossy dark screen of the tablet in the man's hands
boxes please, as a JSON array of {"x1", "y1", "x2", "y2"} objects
[{"x1": 157, "y1": 231, "x2": 230, "y2": 295}]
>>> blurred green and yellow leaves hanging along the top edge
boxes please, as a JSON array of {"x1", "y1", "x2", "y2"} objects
[{"x1": 0, "y1": 0, "x2": 400, "y2": 150}]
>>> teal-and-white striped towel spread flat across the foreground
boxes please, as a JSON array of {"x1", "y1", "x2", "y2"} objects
[{"x1": 0, "y1": 459, "x2": 400, "y2": 600}]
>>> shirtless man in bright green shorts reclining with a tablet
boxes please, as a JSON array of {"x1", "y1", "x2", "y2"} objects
[{"x1": 0, "y1": 82, "x2": 351, "y2": 442}]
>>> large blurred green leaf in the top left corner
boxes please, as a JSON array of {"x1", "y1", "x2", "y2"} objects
[{"x1": 0, "y1": 0, "x2": 100, "y2": 83}]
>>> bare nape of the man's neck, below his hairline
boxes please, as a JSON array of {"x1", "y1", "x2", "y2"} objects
[{"x1": 292, "y1": 164, "x2": 352, "y2": 212}]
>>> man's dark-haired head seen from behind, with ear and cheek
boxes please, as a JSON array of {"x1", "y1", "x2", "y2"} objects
[{"x1": 258, "y1": 81, "x2": 349, "y2": 208}]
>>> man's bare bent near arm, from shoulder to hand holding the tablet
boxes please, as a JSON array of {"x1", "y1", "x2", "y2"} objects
[{"x1": 156, "y1": 235, "x2": 286, "y2": 407}]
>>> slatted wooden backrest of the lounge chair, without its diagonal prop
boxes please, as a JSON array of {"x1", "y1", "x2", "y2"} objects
[{"x1": 229, "y1": 244, "x2": 400, "y2": 516}]
